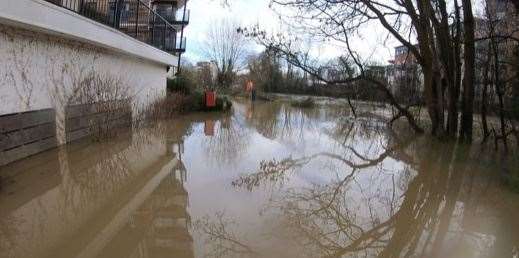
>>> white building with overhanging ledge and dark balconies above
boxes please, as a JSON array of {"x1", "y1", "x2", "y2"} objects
[{"x1": 0, "y1": 0, "x2": 189, "y2": 163}]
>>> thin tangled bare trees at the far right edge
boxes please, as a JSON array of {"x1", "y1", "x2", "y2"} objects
[{"x1": 475, "y1": 1, "x2": 519, "y2": 151}]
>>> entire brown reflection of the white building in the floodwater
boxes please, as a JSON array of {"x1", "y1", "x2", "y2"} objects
[{"x1": 0, "y1": 126, "x2": 193, "y2": 258}]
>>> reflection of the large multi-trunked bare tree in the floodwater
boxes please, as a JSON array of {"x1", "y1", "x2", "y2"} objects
[{"x1": 233, "y1": 124, "x2": 519, "y2": 257}]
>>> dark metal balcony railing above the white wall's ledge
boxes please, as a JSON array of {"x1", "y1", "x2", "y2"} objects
[{"x1": 45, "y1": 0, "x2": 189, "y2": 53}]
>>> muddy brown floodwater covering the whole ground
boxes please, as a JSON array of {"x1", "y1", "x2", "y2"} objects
[{"x1": 0, "y1": 101, "x2": 519, "y2": 258}]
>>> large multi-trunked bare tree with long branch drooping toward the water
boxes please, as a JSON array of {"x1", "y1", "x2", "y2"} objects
[{"x1": 242, "y1": 0, "x2": 486, "y2": 139}]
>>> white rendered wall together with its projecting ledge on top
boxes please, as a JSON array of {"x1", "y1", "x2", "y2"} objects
[{"x1": 0, "y1": 0, "x2": 178, "y2": 143}]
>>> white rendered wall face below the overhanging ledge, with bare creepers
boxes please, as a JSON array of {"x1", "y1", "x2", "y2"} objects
[{"x1": 0, "y1": 24, "x2": 167, "y2": 144}]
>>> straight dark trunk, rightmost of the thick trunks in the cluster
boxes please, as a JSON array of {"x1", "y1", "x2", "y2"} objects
[{"x1": 460, "y1": 0, "x2": 475, "y2": 141}]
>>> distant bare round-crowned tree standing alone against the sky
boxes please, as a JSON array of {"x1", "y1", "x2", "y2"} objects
[{"x1": 203, "y1": 19, "x2": 247, "y2": 88}]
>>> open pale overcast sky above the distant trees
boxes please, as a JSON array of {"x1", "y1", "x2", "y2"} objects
[{"x1": 184, "y1": 0, "x2": 398, "y2": 63}]
